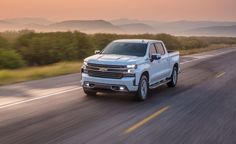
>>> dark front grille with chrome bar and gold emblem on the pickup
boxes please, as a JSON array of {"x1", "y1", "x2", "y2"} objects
[{"x1": 86, "y1": 63, "x2": 127, "y2": 79}]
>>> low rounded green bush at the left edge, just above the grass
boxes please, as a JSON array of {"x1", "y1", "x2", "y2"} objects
[{"x1": 0, "y1": 50, "x2": 25, "y2": 69}]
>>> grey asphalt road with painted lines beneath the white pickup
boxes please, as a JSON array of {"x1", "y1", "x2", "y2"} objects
[{"x1": 0, "y1": 49, "x2": 236, "y2": 144}]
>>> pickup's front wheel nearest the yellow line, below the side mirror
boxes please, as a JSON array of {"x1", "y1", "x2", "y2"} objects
[{"x1": 135, "y1": 75, "x2": 149, "y2": 101}]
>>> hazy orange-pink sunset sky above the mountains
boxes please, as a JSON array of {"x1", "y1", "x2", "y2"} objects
[{"x1": 0, "y1": 0, "x2": 236, "y2": 21}]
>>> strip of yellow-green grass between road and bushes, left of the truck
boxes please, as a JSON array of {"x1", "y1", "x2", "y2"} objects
[{"x1": 0, "y1": 62, "x2": 81, "y2": 85}]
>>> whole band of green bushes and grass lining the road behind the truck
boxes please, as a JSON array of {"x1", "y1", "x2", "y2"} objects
[{"x1": 0, "y1": 30, "x2": 236, "y2": 85}]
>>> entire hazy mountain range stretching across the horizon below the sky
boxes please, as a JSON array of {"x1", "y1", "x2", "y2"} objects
[{"x1": 0, "y1": 18, "x2": 236, "y2": 36}]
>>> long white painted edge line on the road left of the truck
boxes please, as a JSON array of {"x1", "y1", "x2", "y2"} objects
[{"x1": 0, "y1": 87, "x2": 82, "y2": 109}]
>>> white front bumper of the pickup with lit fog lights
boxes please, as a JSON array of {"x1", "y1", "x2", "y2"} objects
[{"x1": 81, "y1": 73, "x2": 138, "y2": 92}]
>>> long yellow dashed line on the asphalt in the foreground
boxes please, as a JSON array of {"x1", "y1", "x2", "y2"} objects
[{"x1": 124, "y1": 106, "x2": 169, "y2": 134}]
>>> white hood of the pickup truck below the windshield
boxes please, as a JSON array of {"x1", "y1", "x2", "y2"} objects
[{"x1": 85, "y1": 54, "x2": 142, "y2": 65}]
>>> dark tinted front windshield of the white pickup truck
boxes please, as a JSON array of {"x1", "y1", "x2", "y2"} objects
[{"x1": 102, "y1": 42, "x2": 147, "y2": 57}]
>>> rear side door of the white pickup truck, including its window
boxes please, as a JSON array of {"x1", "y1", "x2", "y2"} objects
[{"x1": 155, "y1": 42, "x2": 170, "y2": 80}]
